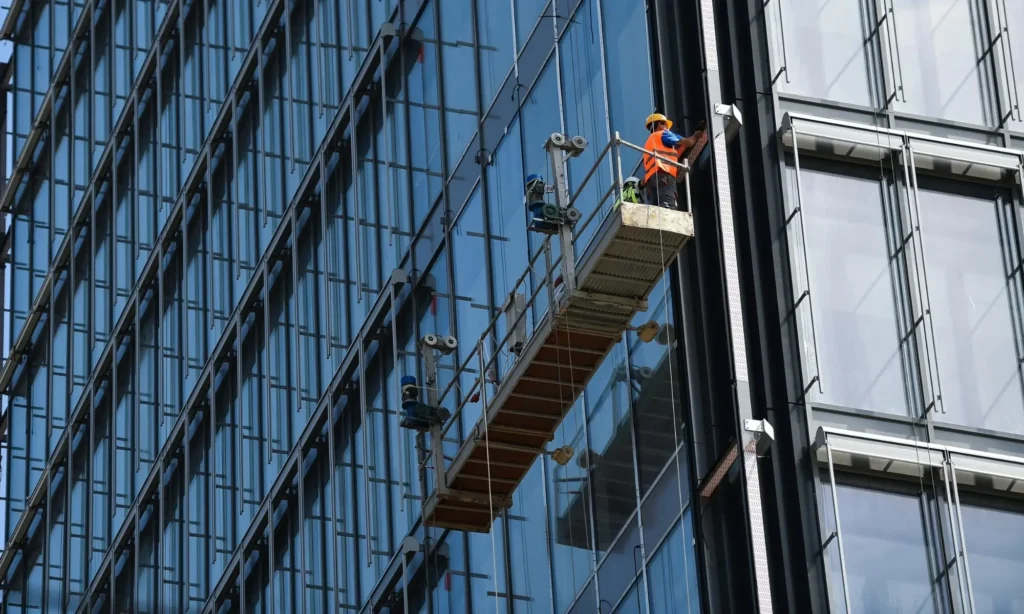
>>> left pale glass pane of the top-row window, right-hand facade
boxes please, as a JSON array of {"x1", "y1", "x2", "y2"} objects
[{"x1": 775, "y1": 0, "x2": 883, "y2": 106}]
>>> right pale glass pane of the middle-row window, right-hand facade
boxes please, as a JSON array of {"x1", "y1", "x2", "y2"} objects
[{"x1": 920, "y1": 181, "x2": 1024, "y2": 433}]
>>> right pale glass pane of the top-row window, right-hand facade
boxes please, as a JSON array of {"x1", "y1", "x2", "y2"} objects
[{"x1": 897, "y1": 0, "x2": 996, "y2": 126}]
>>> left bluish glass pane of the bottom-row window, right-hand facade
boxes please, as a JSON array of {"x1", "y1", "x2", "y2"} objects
[{"x1": 821, "y1": 483, "x2": 951, "y2": 614}]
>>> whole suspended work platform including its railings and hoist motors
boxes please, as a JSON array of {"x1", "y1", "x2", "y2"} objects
[{"x1": 421, "y1": 130, "x2": 693, "y2": 532}]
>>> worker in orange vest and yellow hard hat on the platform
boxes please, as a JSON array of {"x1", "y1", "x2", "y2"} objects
[{"x1": 643, "y1": 113, "x2": 703, "y2": 209}]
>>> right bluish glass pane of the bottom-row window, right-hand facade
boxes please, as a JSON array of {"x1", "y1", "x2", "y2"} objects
[{"x1": 961, "y1": 494, "x2": 1024, "y2": 614}]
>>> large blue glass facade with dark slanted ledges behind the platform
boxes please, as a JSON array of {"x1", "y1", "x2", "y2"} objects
[{"x1": 4, "y1": 0, "x2": 698, "y2": 612}]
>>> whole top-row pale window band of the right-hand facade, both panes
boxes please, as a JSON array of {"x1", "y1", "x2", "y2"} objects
[{"x1": 766, "y1": 0, "x2": 1024, "y2": 130}]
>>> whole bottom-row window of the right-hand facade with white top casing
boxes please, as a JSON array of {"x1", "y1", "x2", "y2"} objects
[{"x1": 818, "y1": 432, "x2": 1024, "y2": 614}]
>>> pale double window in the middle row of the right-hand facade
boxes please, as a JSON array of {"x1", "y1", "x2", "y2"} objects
[{"x1": 786, "y1": 131, "x2": 1024, "y2": 435}]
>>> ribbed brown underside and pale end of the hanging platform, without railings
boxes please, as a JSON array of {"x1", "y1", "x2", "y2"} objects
[{"x1": 423, "y1": 203, "x2": 693, "y2": 532}]
